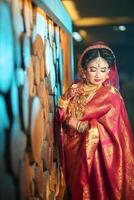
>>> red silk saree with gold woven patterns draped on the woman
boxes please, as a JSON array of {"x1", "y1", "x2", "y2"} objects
[{"x1": 58, "y1": 83, "x2": 134, "y2": 200}]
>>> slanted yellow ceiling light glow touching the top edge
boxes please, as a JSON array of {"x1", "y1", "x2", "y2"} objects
[{"x1": 62, "y1": 0, "x2": 80, "y2": 21}]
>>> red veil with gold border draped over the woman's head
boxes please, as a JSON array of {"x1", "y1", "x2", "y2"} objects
[{"x1": 78, "y1": 41, "x2": 119, "y2": 90}]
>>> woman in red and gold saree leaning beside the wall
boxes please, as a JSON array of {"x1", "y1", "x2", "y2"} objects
[{"x1": 57, "y1": 42, "x2": 134, "y2": 200}]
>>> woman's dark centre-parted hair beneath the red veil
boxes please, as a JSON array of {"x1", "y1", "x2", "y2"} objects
[{"x1": 81, "y1": 48, "x2": 115, "y2": 70}]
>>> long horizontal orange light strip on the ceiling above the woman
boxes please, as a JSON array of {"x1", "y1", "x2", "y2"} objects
[{"x1": 74, "y1": 17, "x2": 134, "y2": 26}]
